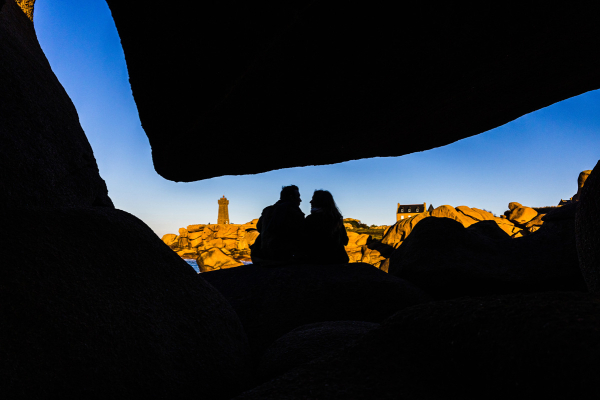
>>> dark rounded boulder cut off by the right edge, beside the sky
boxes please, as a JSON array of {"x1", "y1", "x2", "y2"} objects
[{"x1": 575, "y1": 161, "x2": 600, "y2": 293}]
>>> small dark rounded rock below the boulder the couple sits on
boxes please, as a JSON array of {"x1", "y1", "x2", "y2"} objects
[{"x1": 259, "y1": 321, "x2": 379, "y2": 379}]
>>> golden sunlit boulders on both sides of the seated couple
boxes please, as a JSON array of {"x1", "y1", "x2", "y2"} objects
[{"x1": 162, "y1": 202, "x2": 544, "y2": 272}]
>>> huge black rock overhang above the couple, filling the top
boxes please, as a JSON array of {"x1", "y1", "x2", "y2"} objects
[{"x1": 107, "y1": 0, "x2": 600, "y2": 181}]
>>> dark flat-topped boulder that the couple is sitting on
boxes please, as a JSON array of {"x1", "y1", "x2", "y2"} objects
[{"x1": 201, "y1": 264, "x2": 429, "y2": 358}]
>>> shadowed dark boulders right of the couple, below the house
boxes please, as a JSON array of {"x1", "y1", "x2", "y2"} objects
[{"x1": 389, "y1": 212, "x2": 585, "y2": 299}]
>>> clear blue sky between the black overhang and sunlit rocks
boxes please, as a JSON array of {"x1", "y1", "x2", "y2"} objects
[{"x1": 34, "y1": 0, "x2": 600, "y2": 236}]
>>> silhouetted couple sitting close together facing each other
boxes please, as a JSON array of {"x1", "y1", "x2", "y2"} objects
[{"x1": 251, "y1": 185, "x2": 349, "y2": 265}]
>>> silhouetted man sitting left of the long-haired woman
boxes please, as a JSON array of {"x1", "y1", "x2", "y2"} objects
[{"x1": 251, "y1": 185, "x2": 304, "y2": 264}]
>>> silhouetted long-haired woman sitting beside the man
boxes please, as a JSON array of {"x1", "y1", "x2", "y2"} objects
[{"x1": 303, "y1": 190, "x2": 349, "y2": 264}]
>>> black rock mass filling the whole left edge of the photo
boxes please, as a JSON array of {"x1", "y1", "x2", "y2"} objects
[{"x1": 0, "y1": 0, "x2": 248, "y2": 399}]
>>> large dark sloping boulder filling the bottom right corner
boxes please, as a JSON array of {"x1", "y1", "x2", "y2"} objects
[{"x1": 236, "y1": 293, "x2": 600, "y2": 400}]
